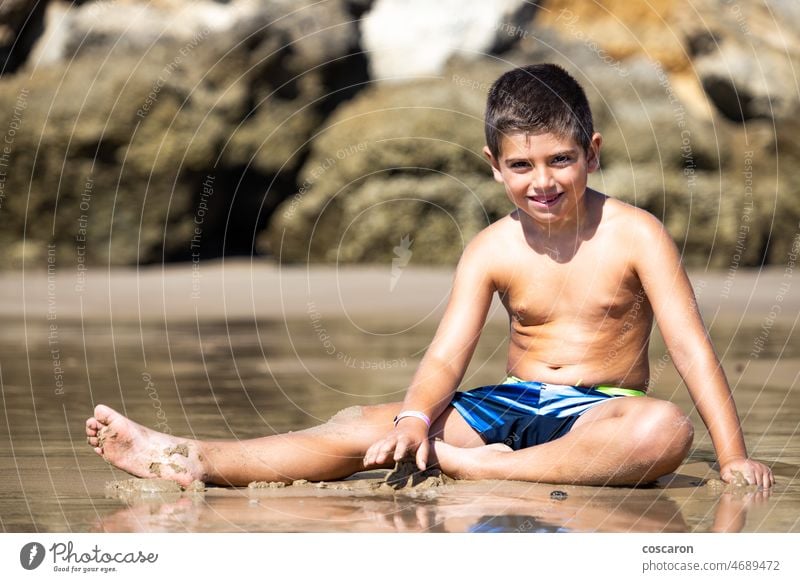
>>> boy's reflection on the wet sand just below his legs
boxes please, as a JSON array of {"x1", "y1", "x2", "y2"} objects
[{"x1": 92, "y1": 474, "x2": 770, "y2": 533}]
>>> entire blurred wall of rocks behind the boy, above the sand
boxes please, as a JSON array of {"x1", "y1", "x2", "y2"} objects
[{"x1": 0, "y1": 0, "x2": 800, "y2": 268}]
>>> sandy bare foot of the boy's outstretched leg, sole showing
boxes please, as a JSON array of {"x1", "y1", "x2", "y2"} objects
[{"x1": 86, "y1": 404, "x2": 205, "y2": 487}]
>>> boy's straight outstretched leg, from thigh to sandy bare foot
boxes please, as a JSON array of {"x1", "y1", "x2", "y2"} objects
[{"x1": 86, "y1": 403, "x2": 483, "y2": 486}]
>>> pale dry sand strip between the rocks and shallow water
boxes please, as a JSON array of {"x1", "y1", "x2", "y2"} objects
[{"x1": 0, "y1": 259, "x2": 800, "y2": 321}]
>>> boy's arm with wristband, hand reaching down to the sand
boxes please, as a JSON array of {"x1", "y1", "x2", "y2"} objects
[{"x1": 364, "y1": 235, "x2": 496, "y2": 469}]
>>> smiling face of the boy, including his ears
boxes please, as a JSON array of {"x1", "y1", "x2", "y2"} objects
[{"x1": 484, "y1": 133, "x2": 602, "y2": 227}]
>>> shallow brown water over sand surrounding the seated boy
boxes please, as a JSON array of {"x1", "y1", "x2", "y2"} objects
[{"x1": 0, "y1": 316, "x2": 800, "y2": 532}]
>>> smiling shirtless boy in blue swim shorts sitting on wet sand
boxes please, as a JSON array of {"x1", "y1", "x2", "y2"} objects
[{"x1": 86, "y1": 65, "x2": 774, "y2": 487}]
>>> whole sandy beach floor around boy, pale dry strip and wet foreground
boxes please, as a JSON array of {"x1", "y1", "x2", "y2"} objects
[{"x1": 0, "y1": 262, "x2": 800, "y2": 532}]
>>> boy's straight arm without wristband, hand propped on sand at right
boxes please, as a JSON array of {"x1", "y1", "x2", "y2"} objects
[{"x1": 632, "y1": 211, "x2": 774, "y2": 487}]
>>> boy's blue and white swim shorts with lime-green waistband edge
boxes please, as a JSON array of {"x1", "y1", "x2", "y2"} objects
[{"x1": 450, "y1": 376, "x2": 644, "y2": 450}]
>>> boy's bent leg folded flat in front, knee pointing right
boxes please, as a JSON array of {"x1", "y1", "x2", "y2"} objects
[{"x1": 434, "y1": 397, "x2": 694, "y2": 485}]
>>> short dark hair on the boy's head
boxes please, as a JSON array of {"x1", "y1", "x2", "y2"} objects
[{"x1": 484, "y1": 64, "x2": 594, "y2": 158}]
